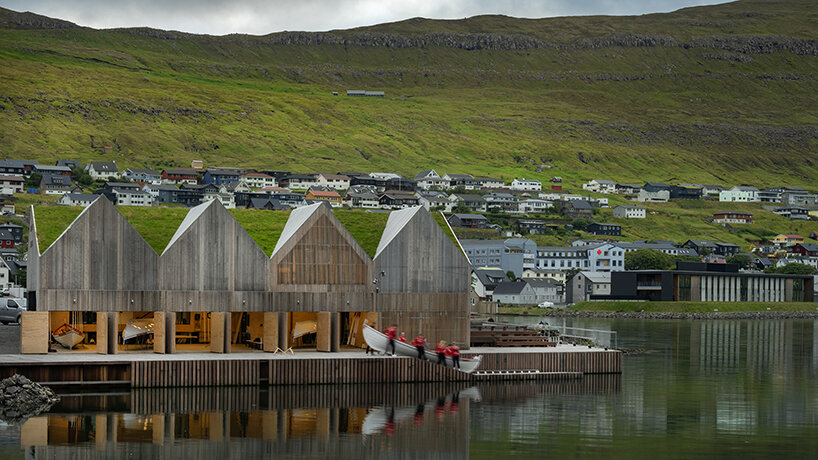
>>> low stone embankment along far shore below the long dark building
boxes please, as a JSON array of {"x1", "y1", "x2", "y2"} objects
[{"x1": 545, "y1": 310, "x2": 818, "y2": 319}]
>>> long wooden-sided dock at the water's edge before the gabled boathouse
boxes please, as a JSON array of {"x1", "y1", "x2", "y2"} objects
[{"x1": 0, "y1": 345, "x2": 622, "y2": 388}]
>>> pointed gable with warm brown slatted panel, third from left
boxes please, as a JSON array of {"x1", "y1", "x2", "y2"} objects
[{"x1": 269, "y1": 203, "x2": 374, "y2": 287}]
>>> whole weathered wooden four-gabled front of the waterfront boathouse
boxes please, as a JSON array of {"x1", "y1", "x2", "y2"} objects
[{"x1": 28, "y1": 199, "x2": 470, "y2": 353}]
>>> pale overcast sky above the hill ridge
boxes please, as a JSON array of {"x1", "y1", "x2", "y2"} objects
[{"x1": 0, "y1": 0, "x2": 725, "y2": 35}]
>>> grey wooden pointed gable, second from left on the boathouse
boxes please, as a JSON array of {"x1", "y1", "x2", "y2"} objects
[{"x1": 159, "y1": 200, "x2": 267, "y2": 291}]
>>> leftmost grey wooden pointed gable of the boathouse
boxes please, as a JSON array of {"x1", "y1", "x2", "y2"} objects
[{"x1": 39, "y1": 199, "x2": 159, "y2": 291}]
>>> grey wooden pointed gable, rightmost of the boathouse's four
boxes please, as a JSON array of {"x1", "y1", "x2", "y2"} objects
[{"x1": 375, "y1": 206, "x2": 471, "y2": 293}]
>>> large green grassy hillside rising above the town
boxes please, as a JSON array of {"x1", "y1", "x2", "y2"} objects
[{"x1": 0, "y1": 0, "x2": 818, "y2": 186}]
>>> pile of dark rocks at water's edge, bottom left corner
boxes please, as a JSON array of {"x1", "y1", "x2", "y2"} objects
[{"x1": 0, "y1": 374, "x2": 60, "y2": 425}]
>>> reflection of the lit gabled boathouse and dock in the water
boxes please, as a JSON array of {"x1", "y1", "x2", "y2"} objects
[{"x1": 20, "y1": 375, "x2": 620, "y2": 459}]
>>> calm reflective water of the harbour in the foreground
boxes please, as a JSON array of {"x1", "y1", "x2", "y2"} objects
[{"x1": 0, "y1": 318, "x2": 818, "y2": 460}]
